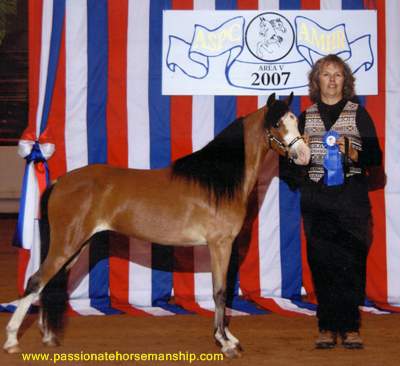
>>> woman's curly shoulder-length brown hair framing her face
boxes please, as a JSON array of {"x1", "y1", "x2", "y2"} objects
[{"x1": 308, "y1": 55, "x2": 355, "y2": 103}]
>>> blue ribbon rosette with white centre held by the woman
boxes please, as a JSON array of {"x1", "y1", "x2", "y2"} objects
[{"x1": 323, "y1": 131, "x2": 344, "y2": 186}]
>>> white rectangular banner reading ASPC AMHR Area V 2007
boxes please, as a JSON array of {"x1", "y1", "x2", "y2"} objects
[{"x1": 162, "y1": 10, "x2": 378, "y2": 95}]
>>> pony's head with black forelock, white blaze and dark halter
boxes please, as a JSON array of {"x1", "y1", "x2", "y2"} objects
[{"x1": 264, "y1": 92, "x2": 311, "y2": 165}]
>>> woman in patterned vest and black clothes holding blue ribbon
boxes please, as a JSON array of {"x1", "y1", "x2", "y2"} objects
[{"x1": 286, "y1": 55, "x2": 382, "y2": 349}]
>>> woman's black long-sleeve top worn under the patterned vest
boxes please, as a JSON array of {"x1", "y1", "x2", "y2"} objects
[{"x1": 280, "y1": 99, "x2": 382, "y2": 189}]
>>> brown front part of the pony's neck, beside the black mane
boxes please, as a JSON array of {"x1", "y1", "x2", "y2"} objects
[{"x1": 243, "y1": 107, "x2": 269, "y2": 201}]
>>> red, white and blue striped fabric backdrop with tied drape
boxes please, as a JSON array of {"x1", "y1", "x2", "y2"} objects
[{"x1": 2, "y1": 0, "x2": 400, "y2": 315}]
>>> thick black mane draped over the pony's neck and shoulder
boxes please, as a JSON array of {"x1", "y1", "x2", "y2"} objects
[{"x1": 172, "y1": 118, "x2": 245, "y2": 204}]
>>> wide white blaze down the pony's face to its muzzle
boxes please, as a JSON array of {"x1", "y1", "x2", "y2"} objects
[{"x1": 282, "y1": 112, "x2": 311, "y2": 165}]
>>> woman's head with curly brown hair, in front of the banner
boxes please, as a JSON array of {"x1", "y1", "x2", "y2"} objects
[{"x1": 308, "y1": 55, "x2": 355, "y2": 104}]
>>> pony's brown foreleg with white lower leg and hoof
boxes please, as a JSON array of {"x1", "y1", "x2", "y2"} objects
[{"x1": 210, "y1": 240, "x2": 241, "y2": 358}]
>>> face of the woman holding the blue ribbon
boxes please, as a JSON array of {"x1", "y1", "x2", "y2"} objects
[{"x1": 319, "y1": 63, "x2": 344, "y2": 104}]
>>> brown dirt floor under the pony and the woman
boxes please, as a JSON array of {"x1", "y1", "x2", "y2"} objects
[{"x1": 0, "y1": 218, "x2": 400, "y2": 366}]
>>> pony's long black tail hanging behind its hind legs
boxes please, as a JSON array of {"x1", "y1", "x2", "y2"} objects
[{"x1": 40, "y1": 185, "x2": 68, "y2": 333}]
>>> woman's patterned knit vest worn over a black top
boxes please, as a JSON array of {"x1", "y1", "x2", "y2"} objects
[{"x1": 304, "y1": 101, "x2": 362, "y2": 182}]
